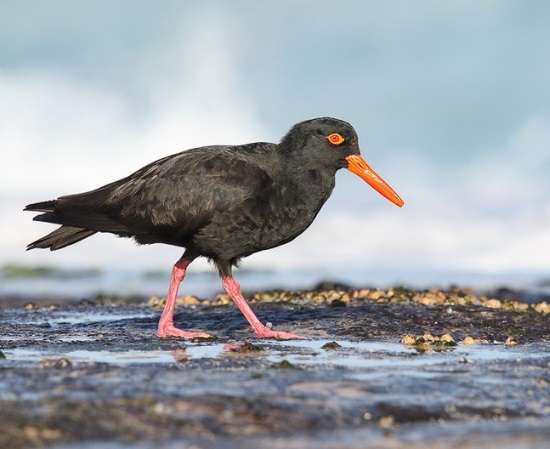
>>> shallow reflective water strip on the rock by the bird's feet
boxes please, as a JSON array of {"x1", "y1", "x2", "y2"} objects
[{"x1": 0, "y1": 338, "x2": 550, "y2": 368}]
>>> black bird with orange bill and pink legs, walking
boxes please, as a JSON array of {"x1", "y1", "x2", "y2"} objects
[{"x1": 25, "y1": 117, "x2": 403, "y2": 339}]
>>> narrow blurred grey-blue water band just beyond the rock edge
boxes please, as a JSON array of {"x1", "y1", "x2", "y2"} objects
[{"x1": 0, "y1": 266, "x2": 550, "y2": 303}]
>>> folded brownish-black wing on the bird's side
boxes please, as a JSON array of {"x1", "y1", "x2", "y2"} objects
[{"x1": 37, "y1": 144, "x2": 278, "y2": 240}]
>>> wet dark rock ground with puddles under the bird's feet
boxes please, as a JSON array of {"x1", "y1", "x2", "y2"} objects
[{"x1": 0, "y1": 289, "x2": 550, "y2": 449}]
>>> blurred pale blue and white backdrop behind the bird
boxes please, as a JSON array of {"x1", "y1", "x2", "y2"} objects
[{"x1": 0, "y1": 0, "x2": 550, "y2": 290}]
